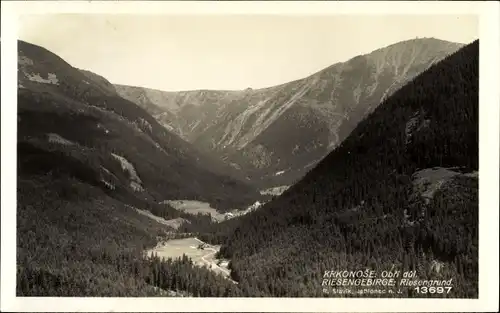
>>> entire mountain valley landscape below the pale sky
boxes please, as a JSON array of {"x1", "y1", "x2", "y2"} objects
[{"x1": 16, "y1": 38, "x2": 479, "y2": 298}]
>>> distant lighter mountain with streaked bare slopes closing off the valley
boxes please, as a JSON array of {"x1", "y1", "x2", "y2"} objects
[{"x1": 115, "y1": 38, "x2": 462, "y2": 188}]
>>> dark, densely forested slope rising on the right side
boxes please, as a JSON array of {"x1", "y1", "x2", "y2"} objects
[{"x1": 205, "y1": 41, "x2": 479, "y2": 298}]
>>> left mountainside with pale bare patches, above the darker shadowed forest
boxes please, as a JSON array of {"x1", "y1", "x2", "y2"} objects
[{"x1": 19, "y1": 42, "x2": 259, "y2": 210}]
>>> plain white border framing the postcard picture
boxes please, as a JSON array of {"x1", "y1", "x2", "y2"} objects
[{"x1": 1, "y1": 1, "x2": 500, "y2": 312}]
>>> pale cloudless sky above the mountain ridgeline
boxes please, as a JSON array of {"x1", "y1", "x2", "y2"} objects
[{"x1": 18, "y1": 14, "x2": 479, "y2": 91}]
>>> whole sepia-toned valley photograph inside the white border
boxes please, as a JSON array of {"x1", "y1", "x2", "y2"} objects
[{"x1": 2, "y1": 1, "x2": 498, "y2": 310}]
